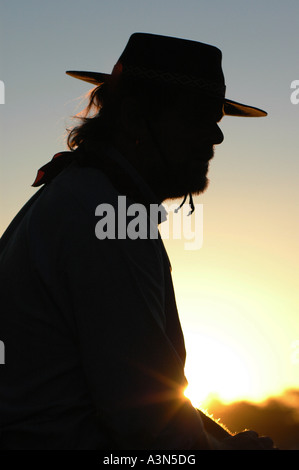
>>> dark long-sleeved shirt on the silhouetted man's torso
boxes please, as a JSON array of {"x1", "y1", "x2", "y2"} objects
[{"x1": 0, "y1": 145, "x2": 207, "y2": 449}]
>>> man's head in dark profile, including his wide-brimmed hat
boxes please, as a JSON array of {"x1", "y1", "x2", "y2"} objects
[{"x1": 67, "y1": 33, "x2": 266, "y2": 200}]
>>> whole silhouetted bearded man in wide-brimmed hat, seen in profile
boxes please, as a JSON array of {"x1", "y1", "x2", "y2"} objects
[{"x1": 0, "y1": 33, "x2": 272, "y2": 450}]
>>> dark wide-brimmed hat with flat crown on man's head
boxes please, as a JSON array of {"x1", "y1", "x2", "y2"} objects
[{"x1": 66, "y1": 33, "x2": 267, "y2": 117}]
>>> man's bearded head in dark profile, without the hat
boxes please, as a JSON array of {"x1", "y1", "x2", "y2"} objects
[{"x1": 115, "y1": 86, "x2": 223, "y2": 200}]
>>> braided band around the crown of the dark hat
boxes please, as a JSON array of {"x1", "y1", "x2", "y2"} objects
[{"x1": 122, "y1": 64, "x2": 226, "y2": 98}]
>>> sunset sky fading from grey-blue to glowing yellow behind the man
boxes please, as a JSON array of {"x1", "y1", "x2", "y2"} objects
[{"x1": 0, "y1": 0, "x2": 299, "y2": 403}]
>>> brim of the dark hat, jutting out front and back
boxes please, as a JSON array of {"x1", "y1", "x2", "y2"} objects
[{"x1": 66, "y1": 70, "x2": 268, "y2": 117}]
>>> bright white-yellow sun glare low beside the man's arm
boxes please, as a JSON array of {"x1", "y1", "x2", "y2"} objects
[{"x1": 166, "y1": 260, "x2": 295, "y2": 409}]
